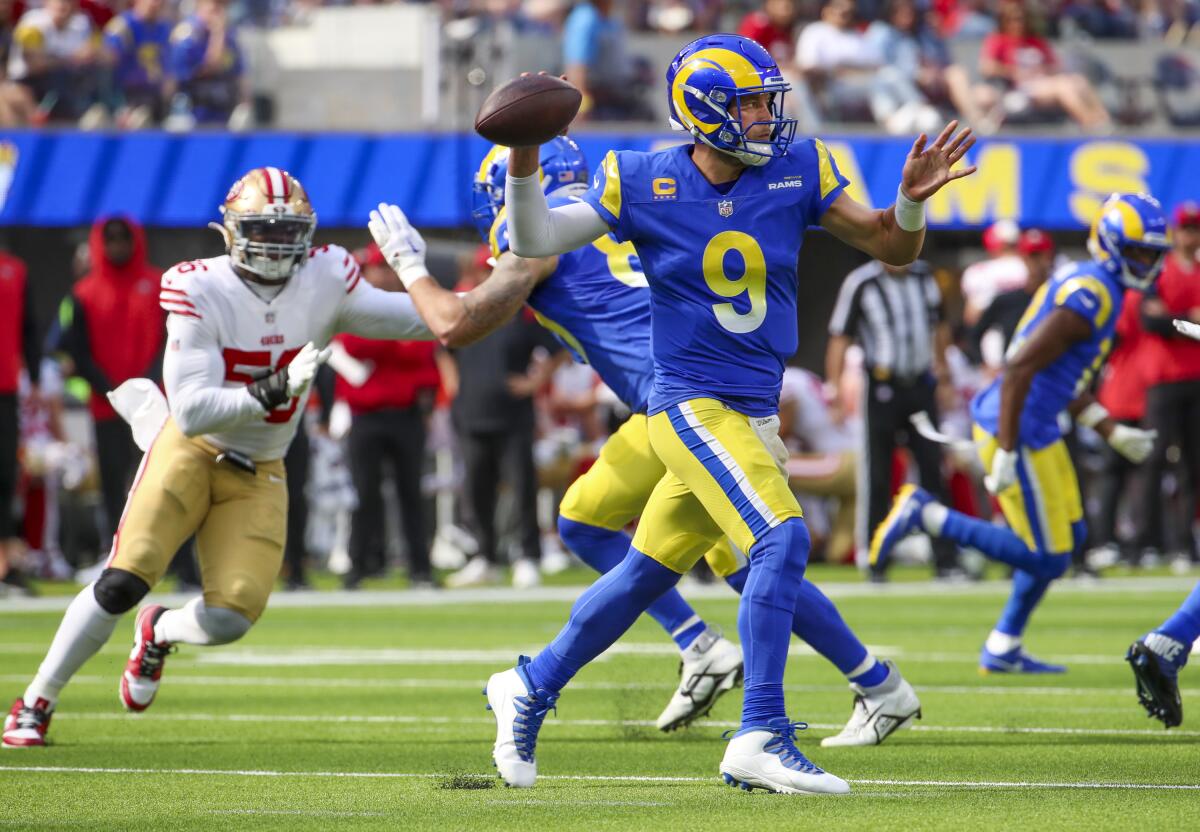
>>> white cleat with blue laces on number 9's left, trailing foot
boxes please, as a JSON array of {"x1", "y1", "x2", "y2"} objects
[{"x1": 484, "y1": 656, "x2": 558, "y2": 789}]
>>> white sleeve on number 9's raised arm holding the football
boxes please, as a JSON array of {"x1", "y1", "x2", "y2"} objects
[{"x1": 504, "y1": 173, "x2": 608, "y2": 257}]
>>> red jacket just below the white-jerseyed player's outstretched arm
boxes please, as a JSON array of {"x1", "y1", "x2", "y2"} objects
[{"x1": 336, "y1": 335, "x2": 442, "y2": 414}]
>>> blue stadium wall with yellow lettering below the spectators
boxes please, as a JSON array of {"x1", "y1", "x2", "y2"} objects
[{"x1": 0, "y1": 131, "x2": 1200, "y2": 231}]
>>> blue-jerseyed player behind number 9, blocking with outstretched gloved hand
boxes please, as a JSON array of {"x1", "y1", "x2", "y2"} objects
[{"x1": 371, "y1": 138, "x2": 920, "y2": 739}]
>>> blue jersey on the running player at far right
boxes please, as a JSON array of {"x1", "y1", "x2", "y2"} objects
[{"x1": 971, "y1": 261, "x2": 1124, "y2": 448}]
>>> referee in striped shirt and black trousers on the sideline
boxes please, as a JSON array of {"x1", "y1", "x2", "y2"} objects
[{"x1": 826, "y1": 261, "x2": 958, "y2": 580}]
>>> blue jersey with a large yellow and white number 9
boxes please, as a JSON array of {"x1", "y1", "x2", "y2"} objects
[{"x1": 583, "y1": 139, "x2": 848, "y2": 415}]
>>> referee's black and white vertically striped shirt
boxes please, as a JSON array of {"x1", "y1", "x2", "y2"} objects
[{"x1": 829, "y1": 261, "x2": 942, "y2": 381}]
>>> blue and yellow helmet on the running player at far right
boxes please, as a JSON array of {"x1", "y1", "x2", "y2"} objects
[{"x1": 1087, "y1": 193, "x2": 1171, "y2": 292}]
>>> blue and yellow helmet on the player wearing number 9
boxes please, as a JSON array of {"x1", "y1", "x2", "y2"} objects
[{"x1": 667, "y1": 35, "x2": 796, "y2": 166}]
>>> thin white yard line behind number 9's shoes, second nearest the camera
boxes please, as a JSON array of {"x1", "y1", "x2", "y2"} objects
[{"x1": 55, "y1": 711, "x2": 1200, "y2": 740}]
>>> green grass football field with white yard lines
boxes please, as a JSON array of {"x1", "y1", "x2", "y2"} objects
[{"x1": 0, "y1": 573, "x2": 1200, "y2": 832}]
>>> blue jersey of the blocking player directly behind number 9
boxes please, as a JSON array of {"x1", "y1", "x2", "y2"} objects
[{"x1": 488, "y1": 198, "x2": 654, "y2": 413}]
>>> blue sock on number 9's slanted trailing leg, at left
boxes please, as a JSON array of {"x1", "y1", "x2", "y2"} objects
[{"x1": 526, "y1": 547, "x2": 680, "y2": 693}]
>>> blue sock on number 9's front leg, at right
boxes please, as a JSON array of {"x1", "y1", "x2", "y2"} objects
[{"x1": 738, "y1": 517, "x2": 811, "y2": 730}]
